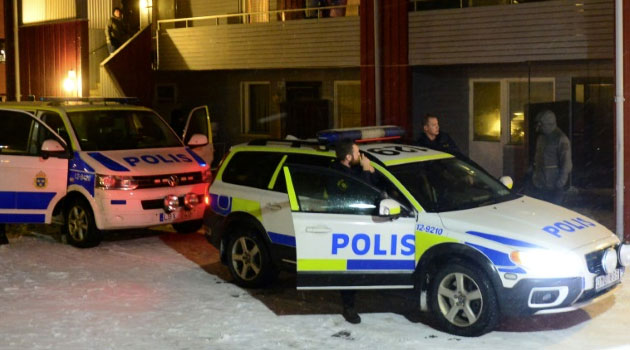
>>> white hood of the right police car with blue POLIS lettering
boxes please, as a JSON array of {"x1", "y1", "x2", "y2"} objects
[{"x1": 439, "y1": 196, "x2": 616, "y2": 250}]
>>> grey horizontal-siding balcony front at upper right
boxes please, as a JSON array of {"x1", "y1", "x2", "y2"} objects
[{"x1": 409, "y1": 0, "x2": 614, "y2": 65}]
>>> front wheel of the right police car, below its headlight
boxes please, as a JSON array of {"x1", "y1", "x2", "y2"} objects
[{"x1": 429, "y1": 263, "x2": 499, "y2": 337}]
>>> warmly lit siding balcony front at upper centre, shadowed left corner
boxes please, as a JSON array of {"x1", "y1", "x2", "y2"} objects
[{"x1": 159, "y1": 17, "x2": 360, "y2": 70}]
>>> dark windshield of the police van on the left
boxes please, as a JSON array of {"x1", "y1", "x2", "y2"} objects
[{"x1": 68, "y1": 110, "x2": 182, "y2": 151}]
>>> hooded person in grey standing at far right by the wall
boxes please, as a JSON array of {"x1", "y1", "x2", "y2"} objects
[{"x1": 532, "y1": 110, "x2": 573, "y2": 205}]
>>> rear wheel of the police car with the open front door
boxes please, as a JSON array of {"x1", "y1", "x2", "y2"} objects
[{"x1": 227, "y1": 227, "x2": 276, "y2": 288}]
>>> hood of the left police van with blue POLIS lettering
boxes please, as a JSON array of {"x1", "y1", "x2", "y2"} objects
[{"x1": 70, "y1": 147, "x2": 207, "y2": 176}]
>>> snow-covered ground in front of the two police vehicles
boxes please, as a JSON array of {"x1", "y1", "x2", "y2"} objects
[{"x1": 0, "y1": 226, "x2": 630, "y2": 350}]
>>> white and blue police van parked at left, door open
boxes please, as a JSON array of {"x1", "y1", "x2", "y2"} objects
[{"x1": 0, "y1": 99, "x2": 212, "y2": 247}]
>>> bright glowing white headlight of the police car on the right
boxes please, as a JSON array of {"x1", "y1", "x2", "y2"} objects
[{"x1": 510, "y1": 249, "x2": 584, "y2": 277}]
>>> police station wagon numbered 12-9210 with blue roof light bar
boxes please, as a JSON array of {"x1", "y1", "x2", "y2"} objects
[{"x1": 206, "y1": 129, "x2": 630, "y2": 336}]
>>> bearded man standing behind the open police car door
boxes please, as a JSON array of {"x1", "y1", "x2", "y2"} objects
[{"x1": 331, "y1": 140, "x2": 374, "y2": 324}]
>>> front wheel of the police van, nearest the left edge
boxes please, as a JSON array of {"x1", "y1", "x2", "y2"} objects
[{"x1": 62, "y1": 199, "x2": 103, "y2": 248}]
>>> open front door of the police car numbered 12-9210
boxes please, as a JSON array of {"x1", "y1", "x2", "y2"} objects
[{"x1": 283, "y1": 164, "x2": 416, "y2": 289}]
